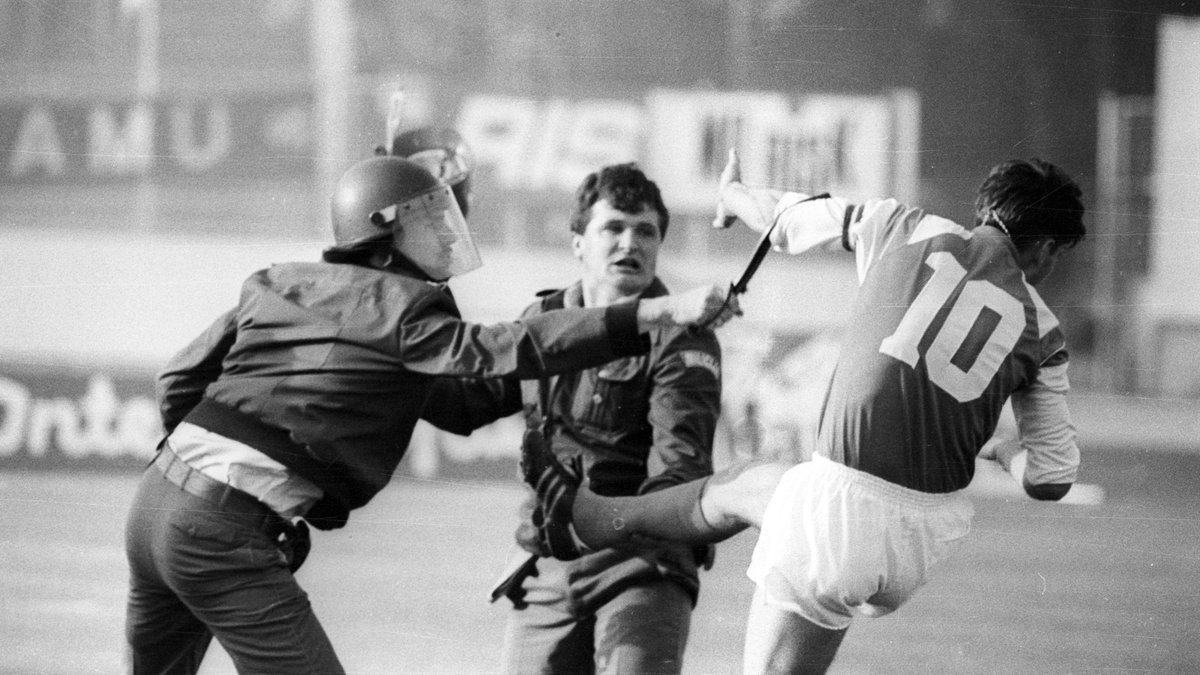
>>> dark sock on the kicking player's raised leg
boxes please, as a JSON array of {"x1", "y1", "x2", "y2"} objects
[{"x1": 571, "y1": 478, "x2": 746, "y2": 550}]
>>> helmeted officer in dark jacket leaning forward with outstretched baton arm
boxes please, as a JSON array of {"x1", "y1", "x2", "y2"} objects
[{"x1": 126, "y1": 156, "x2": 736, "y2": 674}]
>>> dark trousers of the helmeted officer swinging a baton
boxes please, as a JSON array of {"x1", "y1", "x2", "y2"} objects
[{"x1": 125, "y1": 450, "x2": 344, "y2": 675}]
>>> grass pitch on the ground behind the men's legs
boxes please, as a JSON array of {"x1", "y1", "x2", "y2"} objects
[{"x1": 0, "y1": 450, "x2": 1200, "y2": 675}]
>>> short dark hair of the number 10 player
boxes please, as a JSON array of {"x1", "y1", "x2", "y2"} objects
[{"x1": 976, "y1": 157, "x2": 1087, "y2": 250}]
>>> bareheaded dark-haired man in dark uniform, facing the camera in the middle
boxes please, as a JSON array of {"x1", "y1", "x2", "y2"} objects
[{"x1": 434, "y1": 165, "x2": 721, "y2": 674}]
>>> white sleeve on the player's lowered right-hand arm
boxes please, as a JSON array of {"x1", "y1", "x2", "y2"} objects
[{"x1": 1012, "y1": 363, "x2": 1079, "y2": 485}]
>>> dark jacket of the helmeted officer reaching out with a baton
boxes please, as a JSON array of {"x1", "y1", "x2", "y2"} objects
[{"x1": 157, "y1": 262, "x2": 648, "y2": 527}]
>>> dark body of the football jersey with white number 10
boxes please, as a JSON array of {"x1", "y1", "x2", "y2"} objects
[{"x1": 817, "y1": 199, "x2": 1067, "y2": 492}]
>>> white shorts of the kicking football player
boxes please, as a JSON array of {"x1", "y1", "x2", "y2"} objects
[{"x1": 746, "y1": 455, "x2": 974, "y2": 629}]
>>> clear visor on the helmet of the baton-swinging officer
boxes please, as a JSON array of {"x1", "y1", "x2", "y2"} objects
[{"x1": 371, "y1": 185, "x2": 484, "y2": 281}]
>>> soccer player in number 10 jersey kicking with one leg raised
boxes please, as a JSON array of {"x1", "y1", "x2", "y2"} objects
[{"x1": 525, "y1": 151, "x2": 1085, "y2": 673}]
